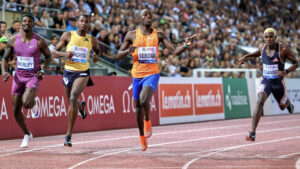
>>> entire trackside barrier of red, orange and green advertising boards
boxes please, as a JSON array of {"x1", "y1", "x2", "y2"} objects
[{"x1": 0, "y1": 76, "x2": 300, "y2": 140}]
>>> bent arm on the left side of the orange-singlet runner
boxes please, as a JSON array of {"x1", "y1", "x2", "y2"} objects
[{"x1": 116, "y1": 31, "x2": 135, "y2": 60}]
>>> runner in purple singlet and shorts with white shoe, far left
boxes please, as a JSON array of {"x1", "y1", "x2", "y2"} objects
[{"x1": 1, "y1": 15, "x2": 51, "y2": 148}]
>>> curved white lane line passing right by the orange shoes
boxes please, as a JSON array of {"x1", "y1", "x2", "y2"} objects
[{"x1": 69, "y1": 126, "x2": 300, "y2": 169}]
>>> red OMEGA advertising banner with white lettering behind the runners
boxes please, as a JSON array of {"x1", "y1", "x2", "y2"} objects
[{"x1": 0, "y1": 76, "x2": 159, "y2": 140}]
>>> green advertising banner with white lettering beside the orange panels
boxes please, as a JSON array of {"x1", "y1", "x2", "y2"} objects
[{"x1": 223, "y1": 78, "x2": 251, "y2": 119}]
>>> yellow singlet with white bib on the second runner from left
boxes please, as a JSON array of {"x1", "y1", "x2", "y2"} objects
[{"x1": 65, "y1": 31, "x2": 92, "y2": 71}]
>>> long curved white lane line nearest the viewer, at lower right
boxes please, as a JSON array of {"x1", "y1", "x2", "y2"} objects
[{"x1": 182, "y1": 136, "x2": 300, "y2": 169}]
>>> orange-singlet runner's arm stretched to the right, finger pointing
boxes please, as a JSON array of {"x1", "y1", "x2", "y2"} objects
[{"x1": 157, "y1": 31, "x2": 196, "y2": 55}]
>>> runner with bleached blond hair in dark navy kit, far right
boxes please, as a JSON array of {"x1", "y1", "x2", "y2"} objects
[{"x1": 239, "y1": 28, "x2": 298, "y2": 141}]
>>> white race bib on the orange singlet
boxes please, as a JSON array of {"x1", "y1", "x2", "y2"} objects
[{"x1": 138, "y1": 47, "x2": 156, "y2": 63}]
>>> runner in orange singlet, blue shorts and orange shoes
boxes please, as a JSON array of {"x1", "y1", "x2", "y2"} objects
[{"x1": 116, "y1": 9, "x2": 195, "y2": 151}]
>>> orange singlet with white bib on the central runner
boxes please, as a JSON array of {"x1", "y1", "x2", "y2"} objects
[{"x1": 132, "y1": 28, "x2": 159, "y2": 78}]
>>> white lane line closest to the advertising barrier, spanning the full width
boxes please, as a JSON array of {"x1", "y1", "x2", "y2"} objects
[{"x1": 0, "y1": 119, "x2": 300, "y2": 157}]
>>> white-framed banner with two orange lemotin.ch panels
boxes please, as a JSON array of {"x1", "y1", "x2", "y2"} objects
[{"x1": 159, "y1": 77, "x2": 224, "y2": 124}]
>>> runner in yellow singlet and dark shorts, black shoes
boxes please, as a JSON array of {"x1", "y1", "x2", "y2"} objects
[{"x1": 54, "y1": 15, "x2": 100, "y2": 147}]
